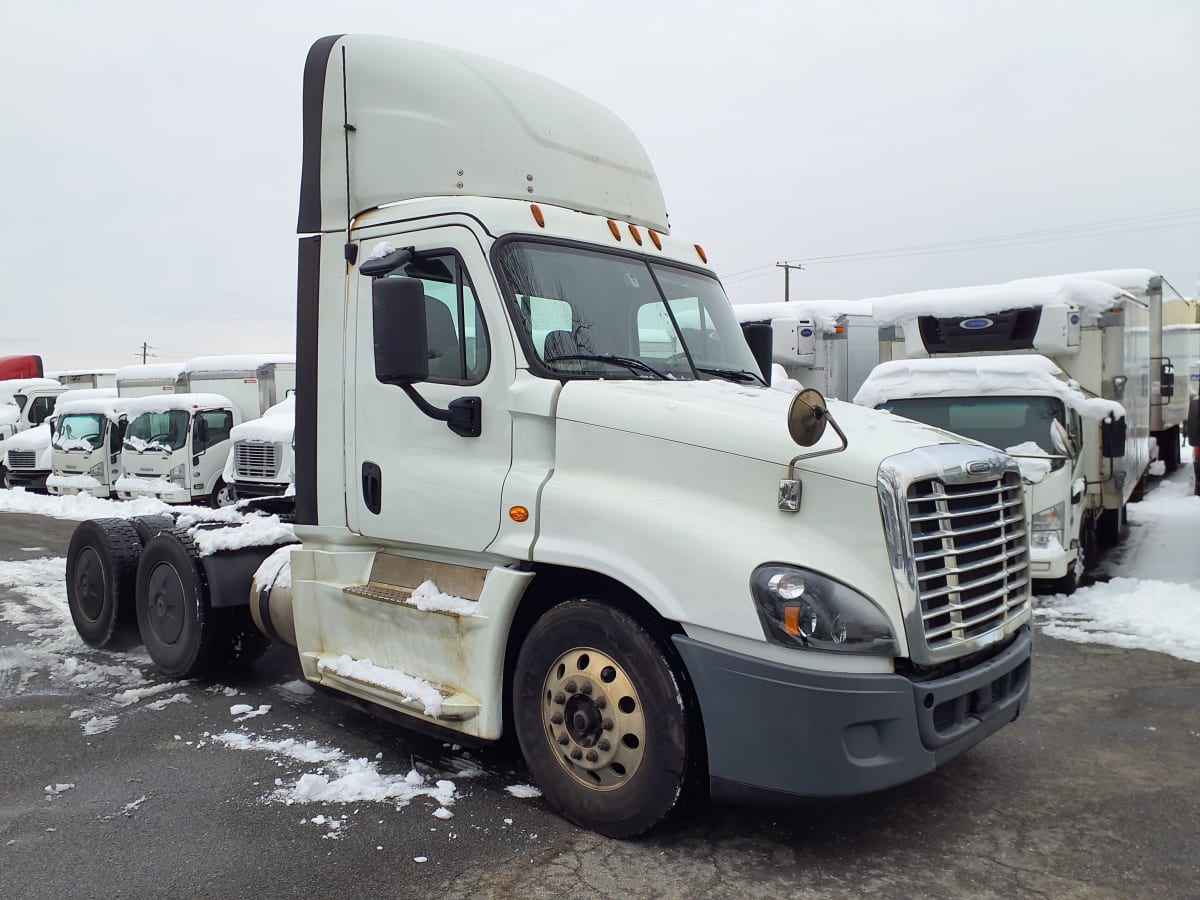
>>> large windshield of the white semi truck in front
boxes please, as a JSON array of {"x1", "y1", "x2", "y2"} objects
[{"x1": 499, "y1": 242, "x2": 762, "y2": 382}]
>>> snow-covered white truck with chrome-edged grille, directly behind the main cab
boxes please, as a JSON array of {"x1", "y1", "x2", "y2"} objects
[{"x1": 222, "y1": 394, "x2": 295, "y2": 500}]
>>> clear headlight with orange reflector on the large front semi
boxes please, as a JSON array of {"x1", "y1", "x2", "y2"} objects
[{"x1": 750, "y1": 563, "x2": 896, "y2": 655}]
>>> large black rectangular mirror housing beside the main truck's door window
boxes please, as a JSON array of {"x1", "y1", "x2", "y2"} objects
[{"x1": 371, "y1": 278, "x2": 430, "y2": 385}]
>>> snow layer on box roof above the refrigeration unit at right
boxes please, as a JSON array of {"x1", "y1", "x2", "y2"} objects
[{"x1": 870, "y1": 276, "x2": 1132, "y2": 325}]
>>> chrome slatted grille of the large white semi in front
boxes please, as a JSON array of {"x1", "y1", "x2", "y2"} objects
[{"x1": 906, "y1": 472, "x2": 1030, "y2": 652}]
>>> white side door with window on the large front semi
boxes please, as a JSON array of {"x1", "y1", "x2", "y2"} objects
[{"x1": 346, "y1": 227, "x2": 515, "y2": 551}]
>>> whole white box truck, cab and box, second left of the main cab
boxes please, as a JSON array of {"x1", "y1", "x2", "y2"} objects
[{"x1": 115, "y1": 354, "x2": 295, "y2": 506}]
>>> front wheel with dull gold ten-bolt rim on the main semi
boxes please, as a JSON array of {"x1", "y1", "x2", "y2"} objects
[{"x1": 512, "y1": 600, "x2": 696, "y2": 838}]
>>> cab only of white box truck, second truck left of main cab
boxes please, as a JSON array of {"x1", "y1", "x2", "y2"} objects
[{"x1": 114, "y1": 394, "x2": 241, "y2": 506}]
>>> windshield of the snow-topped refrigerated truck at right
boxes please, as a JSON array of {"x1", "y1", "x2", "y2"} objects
[{"x1": 880, "y1": 397, "x2": 1067, "y2": 469}]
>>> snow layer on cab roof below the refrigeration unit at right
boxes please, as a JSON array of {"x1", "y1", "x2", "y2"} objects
[{"x1": 854, "y1": 353, "x2": 1124, "y2": 419}]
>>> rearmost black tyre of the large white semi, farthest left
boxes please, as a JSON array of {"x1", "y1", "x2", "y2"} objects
[{"x1": 66, "y1": 518, "x2": 142, "y2": 647}]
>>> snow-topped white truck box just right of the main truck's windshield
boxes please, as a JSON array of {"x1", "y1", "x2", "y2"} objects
[{"x1": 733, "y1": 300, "x2": 880, "y2": 400}]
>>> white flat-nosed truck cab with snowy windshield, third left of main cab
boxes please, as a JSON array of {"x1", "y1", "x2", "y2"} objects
[{"x1": 46, "y1": 391, "x2": 138, "y2": 498}]
